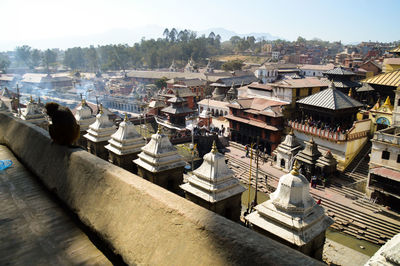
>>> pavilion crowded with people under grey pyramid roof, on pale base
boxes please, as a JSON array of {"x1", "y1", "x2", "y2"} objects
[{"x1": 288, "y1": 82, "x2": 371, "y2": 171}]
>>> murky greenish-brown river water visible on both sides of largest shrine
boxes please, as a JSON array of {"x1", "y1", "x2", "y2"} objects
[{"x1": 242, "y1": 184, "x2": 380, "y2": 256}]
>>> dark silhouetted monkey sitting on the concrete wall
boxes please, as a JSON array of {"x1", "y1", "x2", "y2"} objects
[{"x1": 45, "y1": 102, "x2": 80, "y2": 146}]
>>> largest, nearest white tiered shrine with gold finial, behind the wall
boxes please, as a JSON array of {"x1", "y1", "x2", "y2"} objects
[{"x1": 245, "y1": 161, "x2": 334, "y2": 260}]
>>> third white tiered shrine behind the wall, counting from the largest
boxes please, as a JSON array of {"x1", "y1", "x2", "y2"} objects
[{"x1": 134, "y1": 125, "x2": 185, "y2": 192}]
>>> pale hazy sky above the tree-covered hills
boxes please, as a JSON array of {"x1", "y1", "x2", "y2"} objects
[{"x1": 0, "y1": 0, "x2": 400, "y2": 51}]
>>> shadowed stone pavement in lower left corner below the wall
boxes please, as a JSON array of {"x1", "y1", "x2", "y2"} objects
[{"x1": 0, "y1": 145, "x2": 112, "y2": 265}]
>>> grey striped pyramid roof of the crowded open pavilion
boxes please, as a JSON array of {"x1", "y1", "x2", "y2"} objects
[{"x1": 297, "y1": 84, "x2": 362, "y2": 110}]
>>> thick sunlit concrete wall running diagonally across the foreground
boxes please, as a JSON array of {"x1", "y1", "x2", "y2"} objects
[{"x1": 0, "y1": 113, "x2": 322, "y2": 265}]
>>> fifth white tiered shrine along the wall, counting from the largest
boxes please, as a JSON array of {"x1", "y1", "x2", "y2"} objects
[{"x1": 84, "y1": 106, "x2": 115, "y2": 160}]
